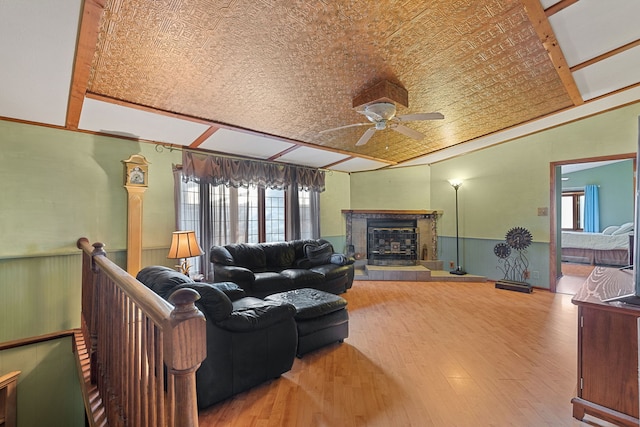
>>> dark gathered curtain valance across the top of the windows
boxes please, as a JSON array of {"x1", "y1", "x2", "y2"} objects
[{"x1": 182, "y1": 150, "x2": 325, "y2": 192}]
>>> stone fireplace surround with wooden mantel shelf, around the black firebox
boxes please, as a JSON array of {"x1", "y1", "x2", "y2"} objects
[{"x1": 342, "y1": 209, "x2": 443, "y2": 261}]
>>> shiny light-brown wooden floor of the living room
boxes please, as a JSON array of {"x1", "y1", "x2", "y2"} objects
[{"x1": 200, "y1": 281, "x2": 611, "y2": 427}]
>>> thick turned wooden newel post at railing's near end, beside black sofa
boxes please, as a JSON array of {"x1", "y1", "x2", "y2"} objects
[{"x1": 164, "y1": 288, "x2": 207, "y2": 427}]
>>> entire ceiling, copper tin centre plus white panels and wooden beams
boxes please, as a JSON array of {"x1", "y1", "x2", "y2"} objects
[{"x1": 0, "y1": 0, "x2": 640, "y2": 172}]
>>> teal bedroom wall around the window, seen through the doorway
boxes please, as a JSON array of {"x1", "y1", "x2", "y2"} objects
[{"x1": 562, "y1": 160, "x2": 634, "y2": 231}]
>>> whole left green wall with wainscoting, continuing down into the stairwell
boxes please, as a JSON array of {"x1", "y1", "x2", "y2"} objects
[{"x1": 0, "y1": 121, "x2": 181, "y2": 426}]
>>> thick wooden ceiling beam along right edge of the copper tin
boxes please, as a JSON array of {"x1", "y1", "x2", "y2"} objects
[{"x1": 521, "y1": 0, "x2": 584, "y2": 106}]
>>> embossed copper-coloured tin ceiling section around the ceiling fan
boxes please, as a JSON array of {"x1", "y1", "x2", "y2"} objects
[{"x1": 88, "y1": 0, "x2": 573, "y2": 163}]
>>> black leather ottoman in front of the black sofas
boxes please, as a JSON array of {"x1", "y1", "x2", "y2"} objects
[{"x1": 265, "y1": 288, "x2": 349, "y2": 358}]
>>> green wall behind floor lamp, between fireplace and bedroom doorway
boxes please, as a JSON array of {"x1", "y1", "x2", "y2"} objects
[{"x1": 431, "y1": 104, "x2": 640, "y2": 287}]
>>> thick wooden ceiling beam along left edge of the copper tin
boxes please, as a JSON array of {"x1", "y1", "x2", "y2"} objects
[{"x1": 65, "y1": 0, "x2": 105, "y2": 130}]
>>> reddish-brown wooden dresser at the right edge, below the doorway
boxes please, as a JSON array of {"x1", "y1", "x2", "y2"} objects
[{"x1": 571, "y1": 267, "x2": 640, "y2": 426}]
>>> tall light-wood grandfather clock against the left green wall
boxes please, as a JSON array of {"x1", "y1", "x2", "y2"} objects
[{"x1": 122, "y1": 154, "x2": 149, "y2": 277}]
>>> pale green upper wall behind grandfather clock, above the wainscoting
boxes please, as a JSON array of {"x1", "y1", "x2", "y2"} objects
[{"x1": 0, "y1": 122, "x2": 181, "y2": 257}]
